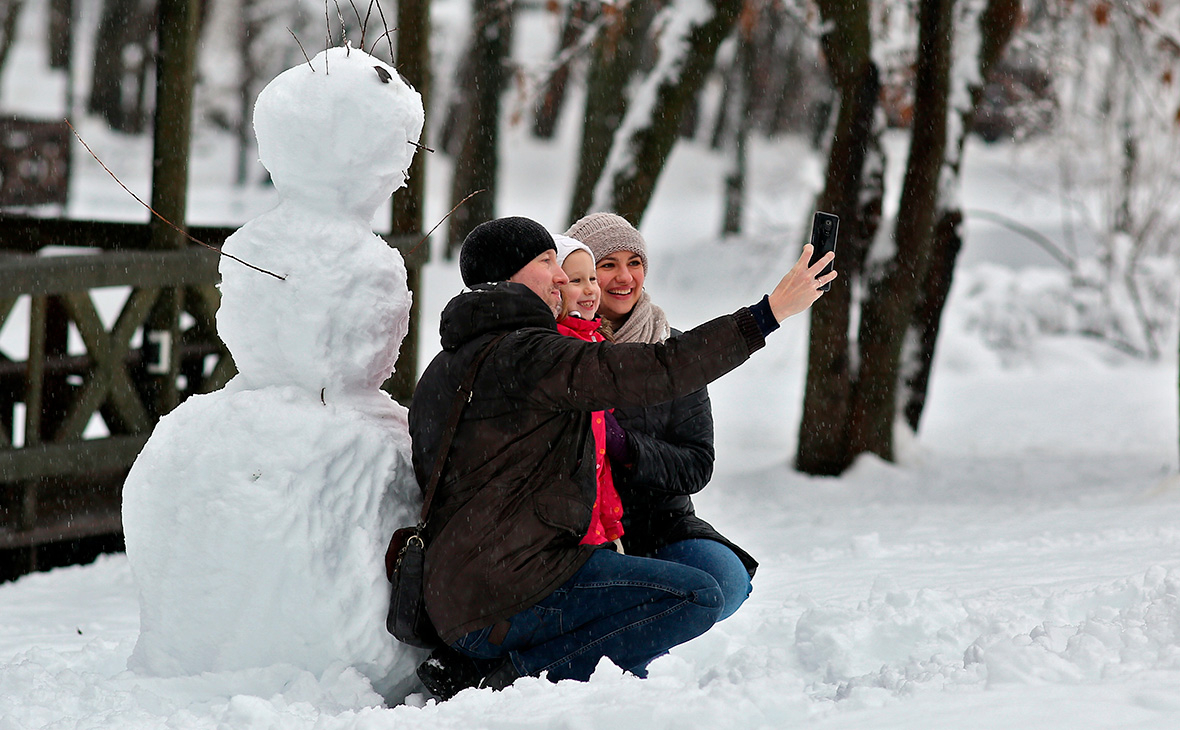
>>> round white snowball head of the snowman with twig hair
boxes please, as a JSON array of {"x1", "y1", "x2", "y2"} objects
[{"x1": 254, "y1": 46, "x2": 424, "y2": 221}]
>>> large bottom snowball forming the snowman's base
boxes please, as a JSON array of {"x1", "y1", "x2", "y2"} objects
[{"x1": 124, "y1": 386, "x2": 420, "y2": 695}]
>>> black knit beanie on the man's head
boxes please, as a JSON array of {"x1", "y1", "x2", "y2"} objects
[{"x1": 459, "y1": 217, "x2": 557, "y2": 287}]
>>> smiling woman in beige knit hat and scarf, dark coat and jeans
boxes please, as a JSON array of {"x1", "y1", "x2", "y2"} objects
[{"x1": 565, "y1": 212, "x2": 758, "y2": 620}]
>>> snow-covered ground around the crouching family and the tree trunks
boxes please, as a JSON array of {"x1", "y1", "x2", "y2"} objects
[{"x1": 0, "y1": 152, "x2": 1180, "y2": 730}]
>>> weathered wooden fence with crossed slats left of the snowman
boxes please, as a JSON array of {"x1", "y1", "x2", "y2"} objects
[{"x1": 0, "y1": 217, "x2": 235, "y2": 579}]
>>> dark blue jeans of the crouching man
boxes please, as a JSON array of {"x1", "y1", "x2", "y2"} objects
[{"x1": 452, "y1": 550, "x2": 725, "y2": 680}]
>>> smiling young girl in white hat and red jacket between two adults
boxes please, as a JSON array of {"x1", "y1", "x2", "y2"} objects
[{"x1": 553, "y1": 235, "x2": 623, "y2": 552}]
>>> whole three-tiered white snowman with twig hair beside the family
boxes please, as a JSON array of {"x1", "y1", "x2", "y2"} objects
[{"x1": 115, "y1": 46, "x2": 422, "y2": 697}]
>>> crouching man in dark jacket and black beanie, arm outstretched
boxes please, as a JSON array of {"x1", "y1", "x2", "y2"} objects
[{"x1": 409, "y1": 218, "x2": 835, "y2": 699}]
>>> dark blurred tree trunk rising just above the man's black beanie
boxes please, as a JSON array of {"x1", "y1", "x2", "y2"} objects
[{"x1": 447, "y1": 0, "x2": 513, "y2": 256}]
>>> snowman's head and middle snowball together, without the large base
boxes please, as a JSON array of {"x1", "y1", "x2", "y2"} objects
[{"x1": 217, "y1": 47, "x2": 422, "y2": 399}]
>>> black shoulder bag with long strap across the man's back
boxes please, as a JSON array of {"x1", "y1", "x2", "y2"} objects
[{"x1": 385, "y1": 333, "x2": 507, "y2": 649}]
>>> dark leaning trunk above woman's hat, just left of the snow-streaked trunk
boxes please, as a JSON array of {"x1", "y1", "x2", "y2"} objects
[{"x1": 569, "y1": 1, "x2": 653, "y2": 223}]
